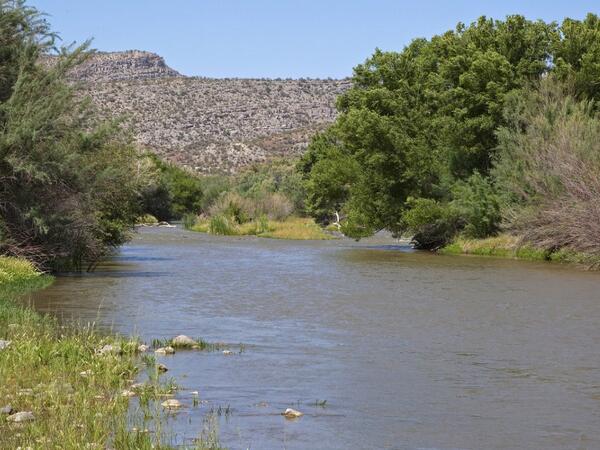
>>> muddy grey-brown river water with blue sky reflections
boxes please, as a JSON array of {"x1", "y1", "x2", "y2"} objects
[{"x1": 25, "y1": 228, "x2": 600, "y2": 450}]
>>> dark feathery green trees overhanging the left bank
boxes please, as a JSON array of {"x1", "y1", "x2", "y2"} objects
[{"x1": 0, "y1": 1, "x2": 142, "y2": 268}]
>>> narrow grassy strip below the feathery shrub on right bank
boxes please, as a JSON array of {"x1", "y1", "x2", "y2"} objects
[{"x1": 438, "y1": 234, "x2": 600, "y2": 268}]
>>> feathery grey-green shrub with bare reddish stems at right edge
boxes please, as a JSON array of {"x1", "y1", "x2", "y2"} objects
[{"x1": 494, "y1": 77, "x2": 600, "y2": 255}]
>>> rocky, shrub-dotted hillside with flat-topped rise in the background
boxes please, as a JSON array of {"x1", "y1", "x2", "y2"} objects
[{"x1": 61, "y1": 51, "x2": 349, "y2": 173}]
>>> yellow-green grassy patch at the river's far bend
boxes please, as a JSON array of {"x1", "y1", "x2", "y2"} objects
[{"x1": 188, "y1": 215, "x2": 334, "y2": 240}]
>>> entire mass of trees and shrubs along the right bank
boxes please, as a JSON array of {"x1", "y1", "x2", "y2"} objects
[{"x1": 298, "y1": 14, "x2": 600, "y2": 262}]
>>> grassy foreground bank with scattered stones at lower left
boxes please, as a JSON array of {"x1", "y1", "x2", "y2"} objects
[{"x1": 0, "y1": 257, "x2": 217, "y2": 450}]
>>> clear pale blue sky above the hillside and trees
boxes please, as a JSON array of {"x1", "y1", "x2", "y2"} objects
[{"x1": 28, "y1": 0, "x2": 600, "y2": 78}]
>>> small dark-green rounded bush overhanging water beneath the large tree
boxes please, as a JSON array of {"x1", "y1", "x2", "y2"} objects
[{"x1": 403, "y1": 198, "x2": 460, "y2": 249}]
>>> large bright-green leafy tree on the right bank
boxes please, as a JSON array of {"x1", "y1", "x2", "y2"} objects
[{"x1": 303, "y1": 15, "x2": 600, "y2": 242}]
